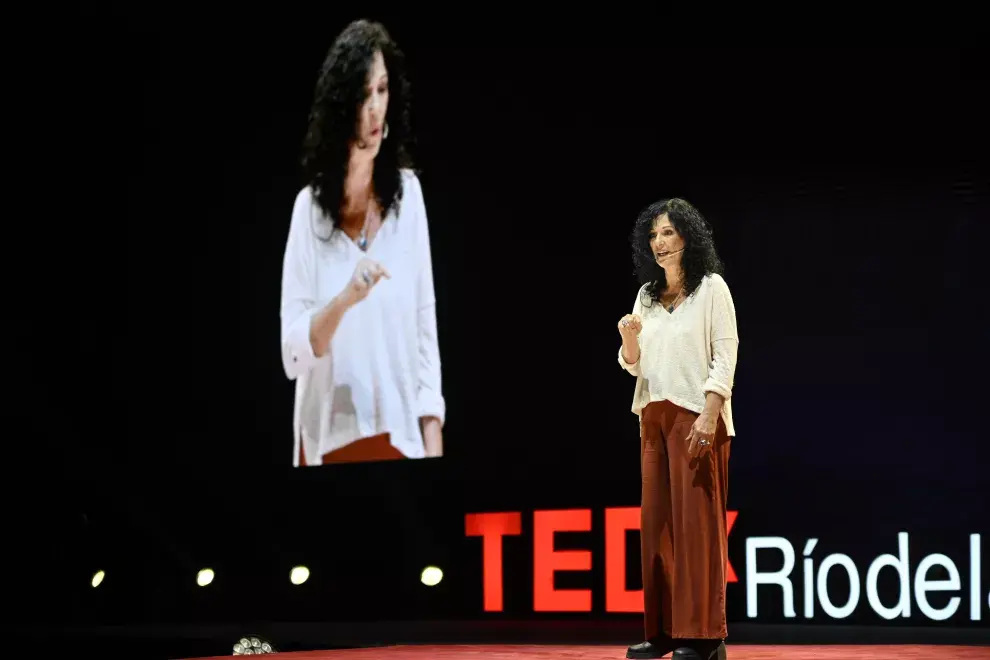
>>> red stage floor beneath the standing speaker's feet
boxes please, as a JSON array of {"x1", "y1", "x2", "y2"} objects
[{"x1": 188, "y1": 644, "x2": 990, "y2": 660}]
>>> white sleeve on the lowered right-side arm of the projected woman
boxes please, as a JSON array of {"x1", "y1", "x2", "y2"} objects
[{"x1": 410, "y1": 175, "x2": 447, "y2": 424}]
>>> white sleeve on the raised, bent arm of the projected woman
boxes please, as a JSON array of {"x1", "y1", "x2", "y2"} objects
[{"x1": 279, "y1": 188, "x2": 319, "y2": 380}]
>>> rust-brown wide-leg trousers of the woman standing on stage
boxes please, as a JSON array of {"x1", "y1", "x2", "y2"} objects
[{"x1": 640, "y1": 401, "x2": 731, "y2": 640}]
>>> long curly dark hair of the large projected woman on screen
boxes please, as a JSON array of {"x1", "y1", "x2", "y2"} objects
[{"x1": 302, "y1": 20, "x2": 412, "y2": 236}]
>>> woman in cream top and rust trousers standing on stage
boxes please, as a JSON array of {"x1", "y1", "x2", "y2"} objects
[{"x1": 618, "y1": 199, "x2": 739, "y2": 660}]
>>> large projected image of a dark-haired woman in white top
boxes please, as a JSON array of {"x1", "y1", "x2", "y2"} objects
[{"x1": 281, "y1": 21, "x2": 445, "y2": 466}]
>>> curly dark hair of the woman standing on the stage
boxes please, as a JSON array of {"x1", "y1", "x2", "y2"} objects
[{"x1": 630, "y1": 198, "x2": 724, "y2": 306}]
